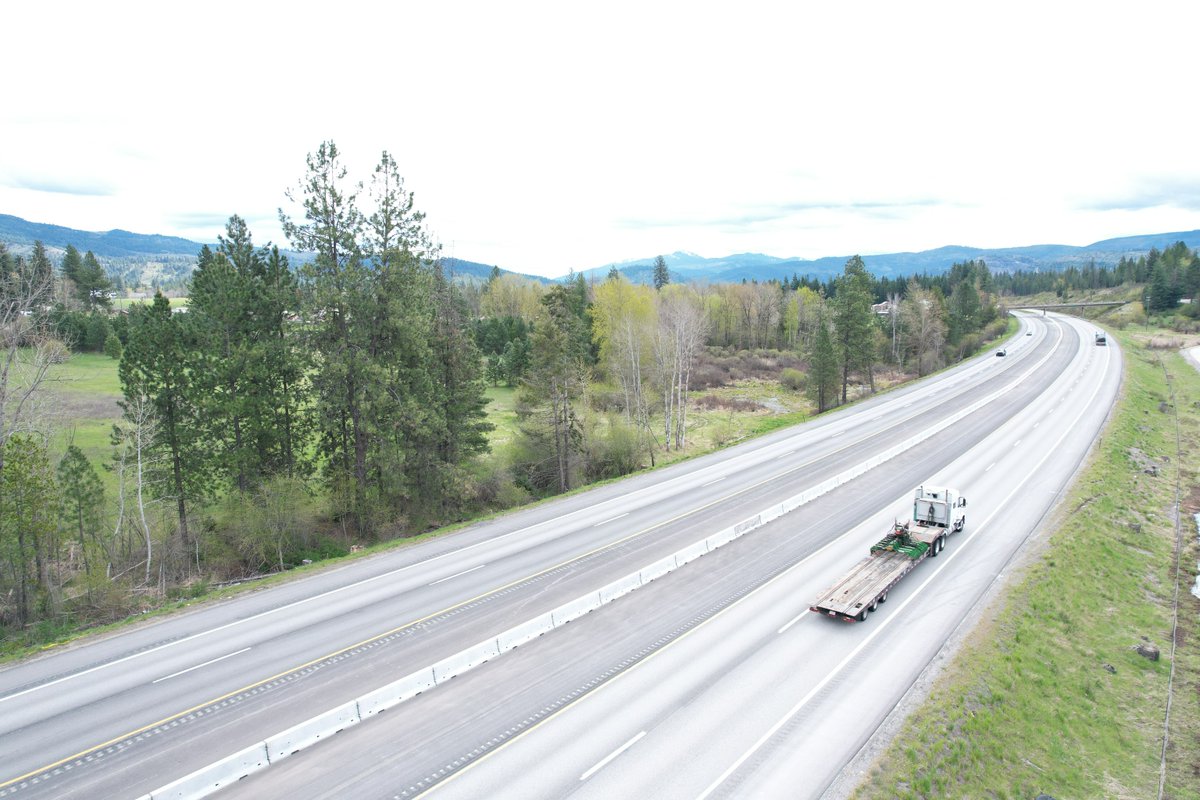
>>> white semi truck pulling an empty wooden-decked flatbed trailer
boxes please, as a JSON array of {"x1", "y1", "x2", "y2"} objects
[{"x1": 809, "y1": 486, "x2": 967, "y2": 622}]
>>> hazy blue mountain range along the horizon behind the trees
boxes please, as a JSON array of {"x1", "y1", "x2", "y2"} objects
[{"x1": 0, "y1": 213, "x2": 1200, "y2": 283}]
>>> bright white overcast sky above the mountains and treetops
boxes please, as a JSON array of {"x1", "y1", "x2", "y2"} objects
[{"x1": 0, "y1": 0, "x2": 1200, "y2": 276}]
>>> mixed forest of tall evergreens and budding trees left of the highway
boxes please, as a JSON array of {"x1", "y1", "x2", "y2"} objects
[{"x1": 0, "y1": 143, "x2": 1200, "y2": 640}]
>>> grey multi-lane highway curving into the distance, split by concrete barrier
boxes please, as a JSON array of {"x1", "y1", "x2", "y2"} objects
[{"x1": 0, "y1": 309, "x2": 1120, "y2": 798}]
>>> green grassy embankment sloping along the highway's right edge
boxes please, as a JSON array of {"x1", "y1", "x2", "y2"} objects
[{"x1": 853, "y1": 327, "x2": 1200, "y2": 800}]
